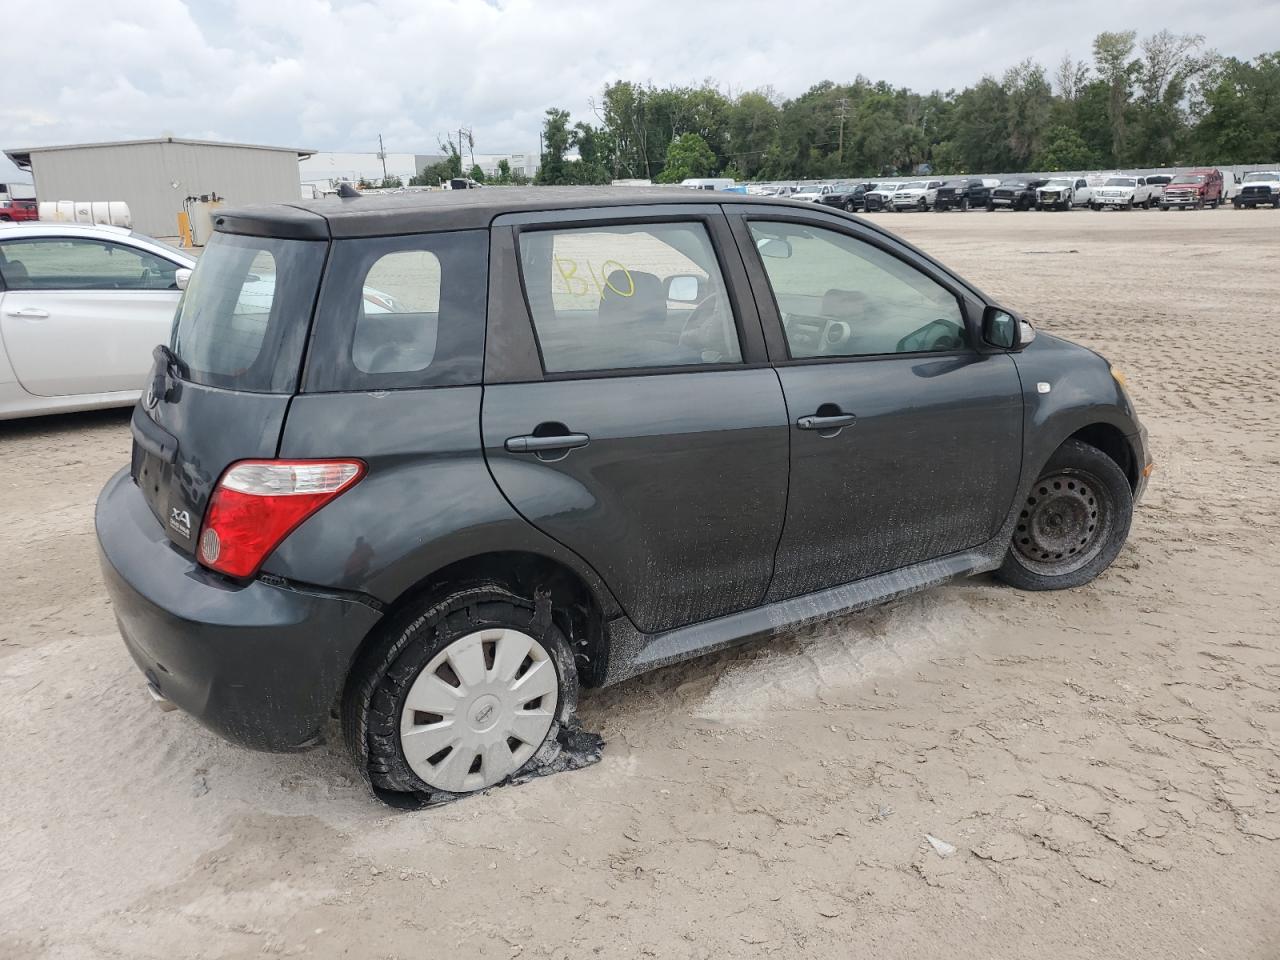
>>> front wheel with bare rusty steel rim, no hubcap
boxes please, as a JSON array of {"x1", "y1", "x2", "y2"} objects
[{"x1": 996, "y1": 440, "x2": 1133, "y2": 590}]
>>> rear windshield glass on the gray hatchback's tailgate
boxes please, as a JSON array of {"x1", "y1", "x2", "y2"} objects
[{"x1": 172, "y1": 233, "x2": 326, "y2": 393}]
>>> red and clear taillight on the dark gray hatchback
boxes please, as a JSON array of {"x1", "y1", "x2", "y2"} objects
[{"x1": 197, "y1": 460, "x2": 365, "y2": 577}]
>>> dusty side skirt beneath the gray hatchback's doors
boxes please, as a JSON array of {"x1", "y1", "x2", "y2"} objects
[{"x1": 602, "y1": 545, "x2": 1009, "y2": 686}]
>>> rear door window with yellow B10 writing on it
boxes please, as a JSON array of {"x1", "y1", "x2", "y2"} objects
[{"x1": 520, "y1": 223, "x2": 742, "y2": 374}]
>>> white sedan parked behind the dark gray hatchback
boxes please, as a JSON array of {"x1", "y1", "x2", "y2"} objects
[{"x1": 0, "y1": 221, "x2": 196, "y2": 420}]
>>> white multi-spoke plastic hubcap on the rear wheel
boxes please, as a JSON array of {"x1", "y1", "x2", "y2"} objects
[{"x1": 401, "y1": 627, "x2": 559, "y2": 794}]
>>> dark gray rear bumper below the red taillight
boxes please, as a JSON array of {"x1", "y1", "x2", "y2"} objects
[{"x1": 95, "y1": 470, "x2": 380, "y2": 750}]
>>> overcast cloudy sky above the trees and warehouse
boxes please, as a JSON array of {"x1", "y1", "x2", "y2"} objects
[{"x1": 0, "y1": 0, "x2": 1280, "y2": 180}]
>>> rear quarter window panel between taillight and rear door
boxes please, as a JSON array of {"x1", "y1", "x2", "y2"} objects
[{"x1": 305, "y1": 230, "x2": 489, "y2": 393}]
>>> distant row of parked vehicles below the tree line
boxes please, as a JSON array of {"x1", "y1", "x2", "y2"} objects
[{"x1": 757, "y1": 168, "x2": 1280, "y2": 214}]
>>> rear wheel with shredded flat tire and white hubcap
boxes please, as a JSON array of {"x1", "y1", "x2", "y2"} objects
[{"x1": 342, "y1": 585, "x2": 577, "y2": 803}]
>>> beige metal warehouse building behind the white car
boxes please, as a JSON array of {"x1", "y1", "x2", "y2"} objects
[{"x1": 4, "y1": 137, "x2": 316, "y2": 237}]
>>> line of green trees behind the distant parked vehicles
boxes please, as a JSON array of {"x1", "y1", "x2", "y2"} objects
[{"x1": 536, "y1": 29, "x2": 1280, "y2": 183}]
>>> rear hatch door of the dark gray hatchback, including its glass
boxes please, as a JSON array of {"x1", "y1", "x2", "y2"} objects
[{"x1": 131, "y1": 227, "x2": 328, "y2": 553}]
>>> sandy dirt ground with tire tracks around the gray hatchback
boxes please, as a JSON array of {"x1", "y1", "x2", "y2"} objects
[{"x1": 0, "y1": 211, "x2": 1280, "y2": 960}]
